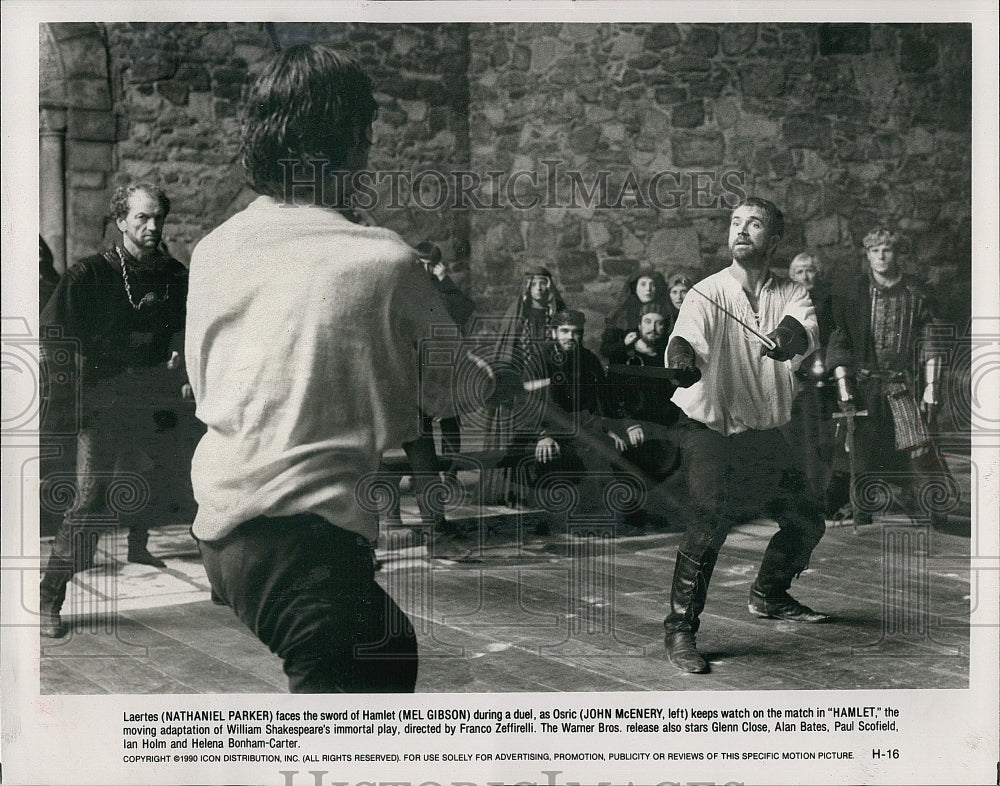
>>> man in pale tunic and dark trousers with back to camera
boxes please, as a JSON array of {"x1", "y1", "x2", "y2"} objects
[{"x1": 186, "y1": 44, "x2": 453, "y2": 693}]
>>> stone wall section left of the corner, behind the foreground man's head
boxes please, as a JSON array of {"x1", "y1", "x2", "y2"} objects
[{"x1": 100, "y1": 23, "x2": 468, "y2": 261}]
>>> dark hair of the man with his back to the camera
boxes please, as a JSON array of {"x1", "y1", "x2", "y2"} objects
[{"x1": 240, "y1": 44, "x2": 378, "y2": 198}]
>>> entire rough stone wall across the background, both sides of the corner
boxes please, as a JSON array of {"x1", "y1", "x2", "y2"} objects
[{"x1": 42, "y1": 23, "x2": 971, "y2": 343}]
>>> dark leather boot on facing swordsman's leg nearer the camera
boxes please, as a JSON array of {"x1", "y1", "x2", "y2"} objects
[{"x1": 663, "y1": 551, "x2": 719, "y2": 674}]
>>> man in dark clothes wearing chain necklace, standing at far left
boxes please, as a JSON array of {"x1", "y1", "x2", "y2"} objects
[{"x1": 39, "y1": 183, "x2": 187, "y2": 638}]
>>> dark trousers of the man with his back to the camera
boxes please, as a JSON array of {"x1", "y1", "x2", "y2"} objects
[{"x1": 199, "y1": 514, "x2": 417, "y2": 693}]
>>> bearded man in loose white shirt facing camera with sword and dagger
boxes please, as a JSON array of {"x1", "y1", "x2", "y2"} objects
[{"x1": 663, "y1": 197, "x2": 827, "y2": 673}]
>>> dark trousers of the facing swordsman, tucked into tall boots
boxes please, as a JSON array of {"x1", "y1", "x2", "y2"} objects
[{"x1": 680, "y1": 418, "x2": 826, "y2": 597}]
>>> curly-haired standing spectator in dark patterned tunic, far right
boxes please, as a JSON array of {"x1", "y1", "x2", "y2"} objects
[{"x1": 829, "y1": 228, "x2": 949, "y2": 527}]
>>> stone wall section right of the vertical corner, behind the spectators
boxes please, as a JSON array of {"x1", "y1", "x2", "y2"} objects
[{"x1": 469, "y1": 24, "x2": 971, "y2": 344}]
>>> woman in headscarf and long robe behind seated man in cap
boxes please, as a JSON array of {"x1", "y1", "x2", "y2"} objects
[{"x1": 483, "y1": 267, "x2": 566, "y2": 507}]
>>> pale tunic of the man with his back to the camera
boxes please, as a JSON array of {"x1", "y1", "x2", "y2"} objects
[{"x1": 185, "y1": 197, "x2": 453, "y2": 540}]
